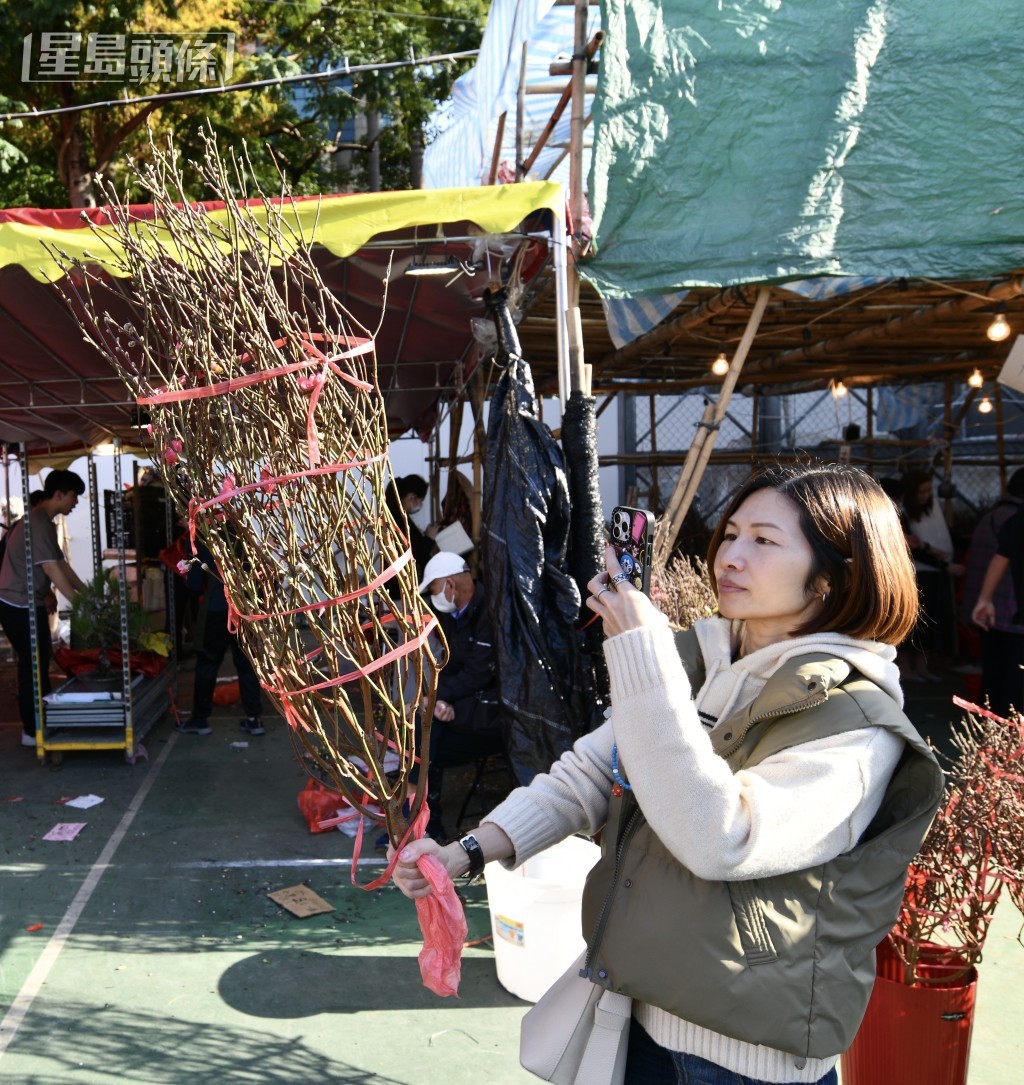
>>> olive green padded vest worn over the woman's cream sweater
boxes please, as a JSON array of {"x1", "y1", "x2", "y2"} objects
[{"x1": 584, "y1": 631, "x2": 943, "y2": 1059}]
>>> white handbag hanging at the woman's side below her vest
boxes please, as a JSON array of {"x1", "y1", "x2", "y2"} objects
[{"x1": 520, "y1": 954, "x2": 632, "y2": 1085}]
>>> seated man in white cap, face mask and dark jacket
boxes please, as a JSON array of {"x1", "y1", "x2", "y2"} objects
[{"x1": 420, "y1": 550, "x2": 503, "y2": 840}]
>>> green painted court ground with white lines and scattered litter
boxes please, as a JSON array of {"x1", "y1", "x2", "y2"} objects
[{"x1": 0, "y1": 659, "x2": 1024, "y2": 1085}]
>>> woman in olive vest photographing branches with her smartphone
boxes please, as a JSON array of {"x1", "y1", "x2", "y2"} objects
[{"x1": 394, "y1": 464, "x2": 943, "y2": 1085}]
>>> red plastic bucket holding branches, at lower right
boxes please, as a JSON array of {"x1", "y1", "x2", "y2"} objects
[{"x1": 842, "y1": 942, "x2": 977, "y2": 1085}]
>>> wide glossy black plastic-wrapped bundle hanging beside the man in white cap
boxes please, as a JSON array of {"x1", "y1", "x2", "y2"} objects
[{"x1": 481, "y1": 297, "x2": 603, "y2": 783}]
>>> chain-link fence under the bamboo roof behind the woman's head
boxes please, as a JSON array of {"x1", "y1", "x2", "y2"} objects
[{"x1": 618, "y1": 382, "x2": 1024, "y2": 553}]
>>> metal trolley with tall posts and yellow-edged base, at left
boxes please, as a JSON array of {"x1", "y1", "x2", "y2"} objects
[{"x1": 21, "y1": 441, "x2": 177, "y2": 765}]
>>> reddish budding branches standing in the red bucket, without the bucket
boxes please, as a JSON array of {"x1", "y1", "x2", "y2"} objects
[{"x1": 888, "y1": 705, "x2": 1024, "y2": 985}]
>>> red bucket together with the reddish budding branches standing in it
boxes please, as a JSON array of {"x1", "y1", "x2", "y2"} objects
[{"x1": 842, "y1": 698, "x2": 1024, "y2": 1085}]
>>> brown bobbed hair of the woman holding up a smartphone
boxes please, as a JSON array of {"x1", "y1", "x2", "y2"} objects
[{"x1": 707, "y1": 463, "x2": 920, "y2": 644}]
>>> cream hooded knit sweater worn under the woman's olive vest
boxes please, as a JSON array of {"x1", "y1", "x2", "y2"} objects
[{"x1": 485, "y1": 617, "x2": 903, "y2": 1083}]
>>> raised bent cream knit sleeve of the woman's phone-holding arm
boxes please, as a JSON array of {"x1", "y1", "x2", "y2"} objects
[{"x1": 605, "y1": 627, "x2": 903, "y2": 880}]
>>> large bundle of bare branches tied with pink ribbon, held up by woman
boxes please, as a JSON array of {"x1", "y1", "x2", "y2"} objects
[{"x1": 56, "y1": 138, "x2": 444, "y2": 844}]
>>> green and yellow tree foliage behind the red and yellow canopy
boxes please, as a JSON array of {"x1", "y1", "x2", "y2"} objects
[{"x1": 0, "y1": 0, "x2": 488, "y2": 207}]
